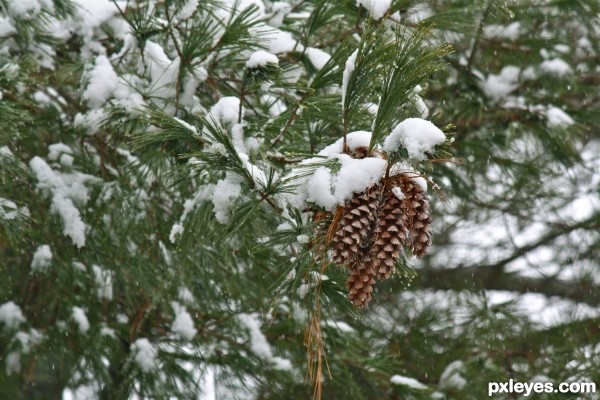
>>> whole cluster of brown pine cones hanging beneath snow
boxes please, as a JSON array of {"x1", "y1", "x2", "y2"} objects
[{"x1": 330, "y1": 147, "x2": 431, "y2": 308}]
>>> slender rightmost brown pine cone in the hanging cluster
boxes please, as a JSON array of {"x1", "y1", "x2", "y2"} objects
[{"x1": 402, "y1": 179, "x2": 431, "y2": 257}]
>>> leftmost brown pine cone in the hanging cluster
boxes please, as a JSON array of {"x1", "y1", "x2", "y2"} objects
[{"x1": 331, "y1": 185, "x2": 381, "y2": 265}]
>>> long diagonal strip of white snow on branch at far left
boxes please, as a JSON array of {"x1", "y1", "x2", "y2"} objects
[{"x1": 29, "y1": 156, "x2": 87, "y2": 247}]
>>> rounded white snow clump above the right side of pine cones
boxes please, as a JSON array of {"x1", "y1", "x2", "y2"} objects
[{"x1": 383, "y1": 118, "x2": 446, "y2": 161}]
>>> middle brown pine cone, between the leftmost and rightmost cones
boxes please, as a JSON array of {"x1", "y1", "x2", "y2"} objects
[{"x1": 371, "y1": 187, "x2": 408, "y2": 279}]
